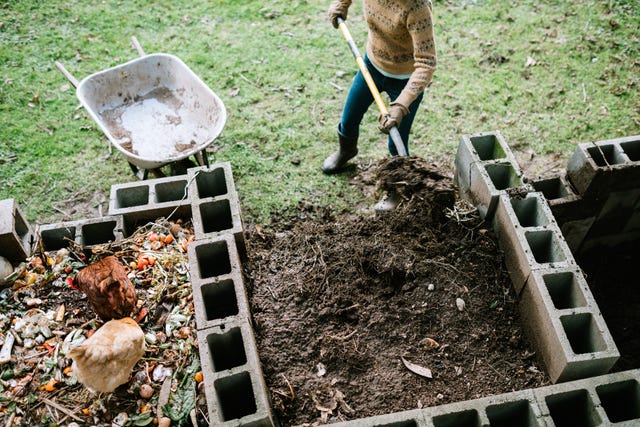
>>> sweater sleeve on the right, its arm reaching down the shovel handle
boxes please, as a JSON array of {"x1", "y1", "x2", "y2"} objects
[{"x1": 394, "y1": 2, "x2": 437, "y2": 108}]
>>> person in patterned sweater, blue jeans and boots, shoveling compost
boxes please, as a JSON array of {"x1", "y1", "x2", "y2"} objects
[{"x1": 322, "y1": 0, "x2": 436, "y2": 210}]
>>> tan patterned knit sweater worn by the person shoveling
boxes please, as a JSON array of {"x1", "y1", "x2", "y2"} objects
[{"x1": 334, "y1": 0, "x2": 436, "y2": 106}]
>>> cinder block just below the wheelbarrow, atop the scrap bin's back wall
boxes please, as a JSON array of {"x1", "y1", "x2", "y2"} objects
[{"x1": 109, "y1": 175, "x2": 191, "y2": 236}]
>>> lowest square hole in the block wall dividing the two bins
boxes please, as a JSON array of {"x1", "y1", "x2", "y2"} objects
[{"x1": 212, "y1": 372, "x2": 258, "y2": 421}]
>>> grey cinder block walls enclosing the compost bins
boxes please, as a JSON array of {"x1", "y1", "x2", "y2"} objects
[{"x1": 0, "y1": 136, "x2": 640, "y2": 427}]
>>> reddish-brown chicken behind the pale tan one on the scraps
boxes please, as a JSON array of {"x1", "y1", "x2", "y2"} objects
[{"x1": 76, "y1": 255, "x2": 138, "y2": 321}]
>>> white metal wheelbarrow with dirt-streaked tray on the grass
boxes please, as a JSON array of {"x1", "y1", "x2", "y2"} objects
[{"x1": 56, "y1": 37, "x2": 227, "y2": 179}]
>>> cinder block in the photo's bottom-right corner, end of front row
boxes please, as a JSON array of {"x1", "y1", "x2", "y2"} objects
[{"x1": 534, "y1": 370, "x2": 640, "y2": 427}]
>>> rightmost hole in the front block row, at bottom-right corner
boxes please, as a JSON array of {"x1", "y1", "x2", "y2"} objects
[{"x1": 596, "y1": 380, "x2": 640, "y2": 423}]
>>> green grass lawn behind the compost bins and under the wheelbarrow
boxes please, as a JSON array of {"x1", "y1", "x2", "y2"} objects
[{"x1": 0, "y1": 0, "x2": 640, "y2": 223}]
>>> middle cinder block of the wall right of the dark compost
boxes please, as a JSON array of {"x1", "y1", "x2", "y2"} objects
[{"x1": 493, "y1": 193, "x2": 577, "y2": 294}]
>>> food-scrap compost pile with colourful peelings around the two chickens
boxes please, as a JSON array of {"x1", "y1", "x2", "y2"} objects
[{"x1": 0, "y1": 219, "x2": 207, "y2": 426}]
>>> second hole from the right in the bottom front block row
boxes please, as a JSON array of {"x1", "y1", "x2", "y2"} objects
[{"x1": 545, "y1": 390, "x2": 601, "y2": 427}]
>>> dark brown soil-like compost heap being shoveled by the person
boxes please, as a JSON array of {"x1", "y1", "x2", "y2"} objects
[{"x1": 245, "y1": 157, "x2": 548, "y2": 426}]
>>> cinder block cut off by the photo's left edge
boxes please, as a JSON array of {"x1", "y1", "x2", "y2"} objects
[{"x1": 0, "y1": 199, "x2": 34, "y2": 263}]
